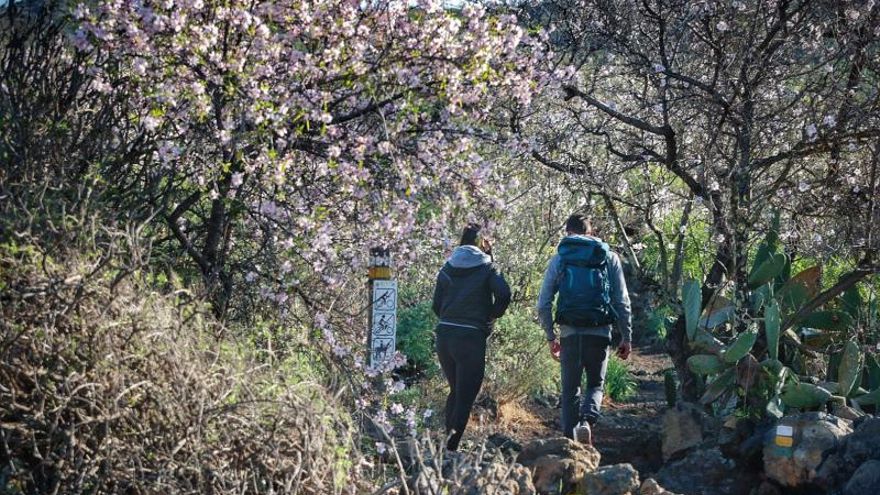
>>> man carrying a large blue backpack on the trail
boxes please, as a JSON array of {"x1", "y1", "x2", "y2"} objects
[{"x1": 538, "y1": 214, "x2": 632, "y2": 444}]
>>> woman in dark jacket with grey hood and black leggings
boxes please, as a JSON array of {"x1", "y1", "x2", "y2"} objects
[{"x1": 433, "y1": 224, "x2": 510, "y2": 450}]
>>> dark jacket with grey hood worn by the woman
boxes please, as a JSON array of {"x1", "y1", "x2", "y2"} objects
[{"x1": 432, "y1": 246, "x2": 511, "y2": 335}]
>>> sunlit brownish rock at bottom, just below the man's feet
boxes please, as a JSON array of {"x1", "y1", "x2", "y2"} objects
[{"x1": 516, "y1": 437, "x2": 600, "y2": 495}]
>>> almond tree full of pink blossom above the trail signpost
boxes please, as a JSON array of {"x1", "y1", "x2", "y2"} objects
[{"x1": 72, "y1": 0, "x2": 545, "y2": 324}]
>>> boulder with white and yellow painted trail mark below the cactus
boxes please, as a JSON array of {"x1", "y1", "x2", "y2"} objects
[{"x1": 764, "y1": 412, "x2": 852, "y2": 487}]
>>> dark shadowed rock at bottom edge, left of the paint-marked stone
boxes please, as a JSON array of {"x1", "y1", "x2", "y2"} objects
[{"x1": 655, "y1": 447, "x2": 757, "y2": 495}]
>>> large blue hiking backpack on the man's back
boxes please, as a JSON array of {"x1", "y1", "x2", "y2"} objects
[{"x1": 556, "y1": 237, "x2": 617, "y2": 327}]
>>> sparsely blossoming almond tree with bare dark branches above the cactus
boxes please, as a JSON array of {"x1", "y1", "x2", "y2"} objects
[{"x1": 522, "y1": 0, "x2": 880, "y2": 400}]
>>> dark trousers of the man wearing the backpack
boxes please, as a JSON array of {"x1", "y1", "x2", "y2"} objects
[{"x1": 559, "y1": 335, "x2": 609, "y2": 438}]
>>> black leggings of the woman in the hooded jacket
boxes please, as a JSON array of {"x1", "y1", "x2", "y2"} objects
[{"x1": 437, "y1": 331, "x2": 486, "y2": 450}]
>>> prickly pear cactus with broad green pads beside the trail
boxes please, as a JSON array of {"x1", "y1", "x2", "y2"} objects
[{"x1": 665, "y1": 227, "x2": 880, "y2": 417}]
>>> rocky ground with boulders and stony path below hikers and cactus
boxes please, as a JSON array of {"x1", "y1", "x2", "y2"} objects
[{"x1": 426, "y1": 345, "x2": 880, "y2": 495}]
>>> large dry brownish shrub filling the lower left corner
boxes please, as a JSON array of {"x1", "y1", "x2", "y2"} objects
[{"x1": 0, "y1": 243, "x2": 357, "y2": 494}]
